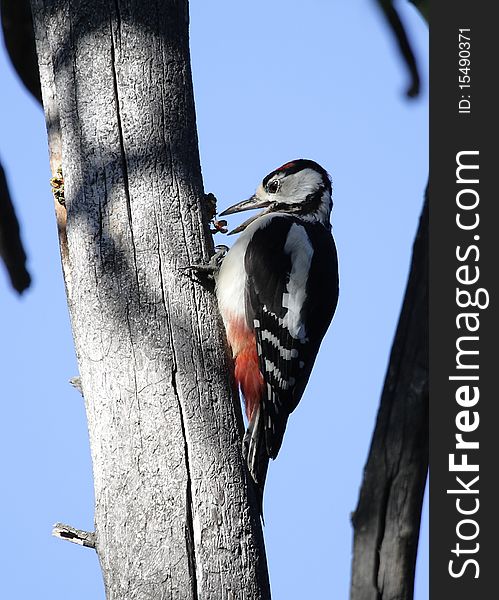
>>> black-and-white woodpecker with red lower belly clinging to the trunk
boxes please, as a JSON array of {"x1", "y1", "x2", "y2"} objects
[{"x1": 216, "y1": 159, "x2": 339, "y2": 508}]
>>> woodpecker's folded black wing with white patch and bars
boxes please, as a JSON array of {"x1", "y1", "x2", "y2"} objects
[{"x1": 245, "y1": 215, "x2": 338, "y2": 458}]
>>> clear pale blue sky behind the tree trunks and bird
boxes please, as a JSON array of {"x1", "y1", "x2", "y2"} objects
[{"x1": 0, "y1": 0, "x2": 428, "y2": 600}]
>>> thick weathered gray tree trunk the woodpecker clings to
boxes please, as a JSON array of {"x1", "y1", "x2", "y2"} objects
[{"x1": 32, "y1": 0, "x2": 270, "y2": 600}]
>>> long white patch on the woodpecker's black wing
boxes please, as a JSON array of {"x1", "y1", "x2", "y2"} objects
[{"x1": 282, "y1": 223, "x2": 314, "y2": 342}]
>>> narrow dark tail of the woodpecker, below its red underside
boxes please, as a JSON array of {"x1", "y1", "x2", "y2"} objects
[{"x1": 243, "y1": 406, "x2": 269, "y2": 520}]
